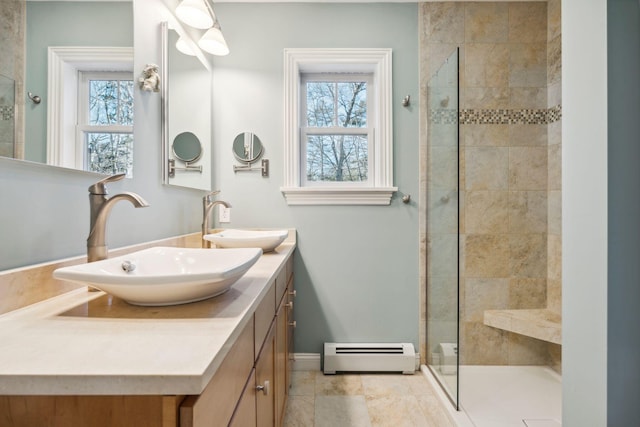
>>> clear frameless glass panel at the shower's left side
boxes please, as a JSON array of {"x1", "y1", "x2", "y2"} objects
[{"x1": 427, "y1": 49, "x2": 460, "y2": 408}]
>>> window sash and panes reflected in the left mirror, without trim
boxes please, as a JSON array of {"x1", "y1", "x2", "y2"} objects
[{"x1": 76, "y1": 72, "x2": 134, "y2": 177}]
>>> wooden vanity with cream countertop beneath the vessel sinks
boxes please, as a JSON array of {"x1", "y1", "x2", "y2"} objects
[{"x1": 0, "y1": 234, "x2": 296, "y2": 427}]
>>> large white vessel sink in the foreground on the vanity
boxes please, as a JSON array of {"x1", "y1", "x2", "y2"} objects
[{"x1": 53, "y1": 247, "x2": 262, "y2": 305}]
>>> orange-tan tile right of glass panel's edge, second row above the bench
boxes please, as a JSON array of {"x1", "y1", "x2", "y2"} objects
[{"x1": 464, "y1": 234, "x2": 510, "y2": 280}]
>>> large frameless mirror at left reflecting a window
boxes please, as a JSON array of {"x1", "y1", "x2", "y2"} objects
[{"x1": 0, "y1": 0, "x2": 134, "y2": 176}]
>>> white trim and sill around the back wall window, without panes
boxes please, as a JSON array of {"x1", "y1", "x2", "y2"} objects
[{"x1": 280, "y1": 49, "x2": 398, "y2": 205}]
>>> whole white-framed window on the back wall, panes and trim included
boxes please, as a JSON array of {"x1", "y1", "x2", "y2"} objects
[{"x1": 281, "y1": 49, "x2": 397, "y2": 205}]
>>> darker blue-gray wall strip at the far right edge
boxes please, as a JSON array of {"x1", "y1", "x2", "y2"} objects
[{"x1": 607, "y1": 0, "x2": 640, "y2": 427}]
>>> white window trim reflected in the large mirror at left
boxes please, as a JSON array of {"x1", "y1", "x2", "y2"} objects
[{"x1": 47, "y1": 46, "x2": 133, "y2": 169}]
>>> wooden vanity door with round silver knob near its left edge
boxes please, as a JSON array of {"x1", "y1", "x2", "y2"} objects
[{"x1": 256, "y1": 322, "x2": 276, "y2": 427}]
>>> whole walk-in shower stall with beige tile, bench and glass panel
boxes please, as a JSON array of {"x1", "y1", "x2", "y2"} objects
[{"x1": 419, "y1": 0, "x2": 562, "y2": 427}]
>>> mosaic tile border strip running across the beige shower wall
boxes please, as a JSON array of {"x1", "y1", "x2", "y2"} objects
[{"x1": 430, "y1": 105, "x2": 562, "y2": 125}]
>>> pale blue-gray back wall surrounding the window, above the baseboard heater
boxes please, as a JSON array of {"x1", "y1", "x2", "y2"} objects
[{"x1": 213, "y1": 3, "x2": 419, "y2": 353}]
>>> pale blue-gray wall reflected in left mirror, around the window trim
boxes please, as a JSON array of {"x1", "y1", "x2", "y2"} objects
[{"x1": 25, "y1": 1, "x2": 133, "y2": 163}]
